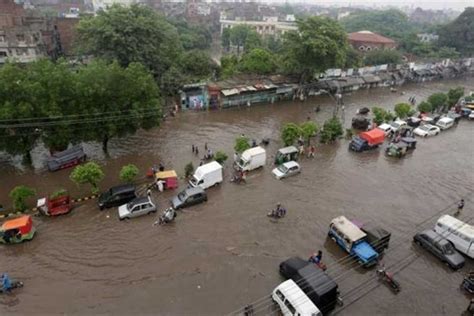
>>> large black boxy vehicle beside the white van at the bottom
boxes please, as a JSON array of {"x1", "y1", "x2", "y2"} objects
[{"x1": 280, "y1": 257, "x2": 340, "y2": 314}]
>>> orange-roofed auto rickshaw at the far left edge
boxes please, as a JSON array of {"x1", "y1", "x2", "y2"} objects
[{"x1": 0, "y1": 215, "x2": 36, "y2": 244}]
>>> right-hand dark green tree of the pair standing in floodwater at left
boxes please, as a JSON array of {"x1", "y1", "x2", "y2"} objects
[{"x1": 76, "y1": 60, "x2": 161, "y2": 152}]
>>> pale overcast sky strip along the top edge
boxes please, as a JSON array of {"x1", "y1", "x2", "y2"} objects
[{"x1": 274, "y1": 0, "x2": 474, "y2": 11}]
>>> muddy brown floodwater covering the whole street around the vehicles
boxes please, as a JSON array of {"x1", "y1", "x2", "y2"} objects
[{"x1": 0, "y1": 78, "x2": 474, "y2": 315}]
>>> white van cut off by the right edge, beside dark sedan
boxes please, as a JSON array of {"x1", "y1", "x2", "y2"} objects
[{"x1": 435, "y1": 215, "x2": 474, "y2": 258}]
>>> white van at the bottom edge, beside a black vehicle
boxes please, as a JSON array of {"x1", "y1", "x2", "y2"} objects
[{"x1": 272, "y1": 279, "x2": 323, "y2": 316}]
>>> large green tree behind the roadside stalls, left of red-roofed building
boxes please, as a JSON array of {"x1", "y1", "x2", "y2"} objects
[{"x1": 281, "y1": 16, "x2": 349, "y2": 82}]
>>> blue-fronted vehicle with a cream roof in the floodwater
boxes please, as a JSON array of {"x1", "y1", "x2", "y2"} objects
[{"x1": 328, "y1": 216, "x2": 379, "y2": 268}]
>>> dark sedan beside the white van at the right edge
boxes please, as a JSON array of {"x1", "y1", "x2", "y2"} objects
[{"x1": 413, "y1": 230, "x2": 464, "y2": 270}]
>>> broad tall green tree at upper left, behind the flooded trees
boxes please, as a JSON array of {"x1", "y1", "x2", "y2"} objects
[{"x1": 76, "y1": 4, "x2": 183, "y2": 77}]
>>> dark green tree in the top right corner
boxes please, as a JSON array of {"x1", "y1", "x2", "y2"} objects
[{"x1": 438, "y1": 7, "x2": 474, "y2": 56}]
